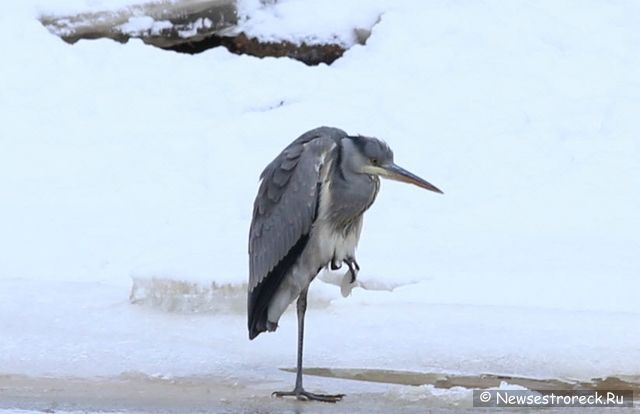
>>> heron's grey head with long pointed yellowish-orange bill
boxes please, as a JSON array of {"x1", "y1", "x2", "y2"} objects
[{"x1": 346, "y1": 136, "x2": 442, "y2": 194}]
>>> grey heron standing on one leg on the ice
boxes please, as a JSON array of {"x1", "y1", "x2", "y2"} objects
[{"x1": 248, "y1": 127, "x2": 442, "y2": 402}]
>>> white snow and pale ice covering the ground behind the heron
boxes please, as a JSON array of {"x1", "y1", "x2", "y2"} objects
[{"x1": 0, "y1": 0, "x2": 640, "y2": 410}]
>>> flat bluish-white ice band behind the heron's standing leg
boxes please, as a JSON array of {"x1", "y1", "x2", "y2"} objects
[{"x1": 0, "y1": 280, "x2": 640, "y2": 380}]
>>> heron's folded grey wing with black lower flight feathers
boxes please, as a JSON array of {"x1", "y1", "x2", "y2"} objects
[{"x1": 248, "y1": 128, "x2": 346, "y2": 337}]
